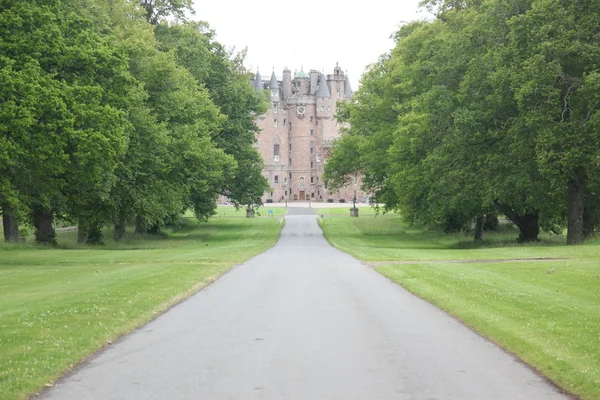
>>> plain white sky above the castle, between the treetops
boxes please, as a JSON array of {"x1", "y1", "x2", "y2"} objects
[{"x1": 193, "y1": 0, "x2": 425, "y2": 90}]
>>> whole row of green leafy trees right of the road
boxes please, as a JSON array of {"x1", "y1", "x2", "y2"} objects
[{"x1": 326, "y1": 0, "x2": 600, "y2": 244}]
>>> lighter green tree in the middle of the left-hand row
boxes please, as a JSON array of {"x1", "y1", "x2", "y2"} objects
[{"x1": 103, "y1": 8, "x2": 235, "y2": 238}]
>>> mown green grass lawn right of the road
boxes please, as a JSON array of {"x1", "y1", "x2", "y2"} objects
[{"x1": 320, "y1": 215, "x2": 600, "y2": 399}]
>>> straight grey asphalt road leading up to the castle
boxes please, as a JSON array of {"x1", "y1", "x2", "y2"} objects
[{"x1": 40, "y1": 208, "x2": 566, "y2": 400}]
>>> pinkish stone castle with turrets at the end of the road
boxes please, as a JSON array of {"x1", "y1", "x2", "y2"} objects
[{"x1": 252, "y1": 65, "x2": 367, "y2": 203}]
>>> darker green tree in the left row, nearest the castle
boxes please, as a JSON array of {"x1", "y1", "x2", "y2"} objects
[{"x1": 156, "y1": 22, "x2": 268, "y2": 206}]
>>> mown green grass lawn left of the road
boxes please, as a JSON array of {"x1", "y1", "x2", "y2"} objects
[{"x1": 0, "y1": 218, "x2": 282, "y2": 399}]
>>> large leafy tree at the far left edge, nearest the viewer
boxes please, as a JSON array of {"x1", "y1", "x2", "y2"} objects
[{"x1": 0, "y1": 0, "x2": 133, "y2": 243}]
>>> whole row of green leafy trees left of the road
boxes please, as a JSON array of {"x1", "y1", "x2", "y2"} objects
[{"x1": 0, "y1": 0, "x2": 268, "y2": 244}]
